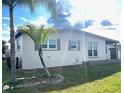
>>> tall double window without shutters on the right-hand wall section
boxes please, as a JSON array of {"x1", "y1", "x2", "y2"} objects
[{"x1": 88, "y1": 42, "x2": 98, "y2": 56}]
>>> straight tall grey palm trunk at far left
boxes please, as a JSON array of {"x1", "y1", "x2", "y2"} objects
[{"x1": 9, "y1": 0, "x2": 17, "y2": 83}]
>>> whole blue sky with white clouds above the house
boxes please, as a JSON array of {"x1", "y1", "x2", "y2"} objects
[{"x1": 2, "y1": 0, "x2": 121, "y2": 45}]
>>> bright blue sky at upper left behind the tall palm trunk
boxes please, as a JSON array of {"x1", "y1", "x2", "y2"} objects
[{"x1": 2, "y1": 6, "x2": 50, "y2": 40}]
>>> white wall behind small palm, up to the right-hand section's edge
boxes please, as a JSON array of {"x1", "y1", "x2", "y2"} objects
[{"x1": 23, "y1": 32, "x2": 83, "y2": 69}]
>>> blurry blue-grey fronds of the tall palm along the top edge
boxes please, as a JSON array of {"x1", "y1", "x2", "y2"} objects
[{"x1": 2, "y1": 0, "x2": 58, "y2": 17}]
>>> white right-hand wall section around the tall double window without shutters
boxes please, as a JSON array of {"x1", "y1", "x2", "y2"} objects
[{"x1": 85, "y1": 35, "x2": 106, "y2": 61}]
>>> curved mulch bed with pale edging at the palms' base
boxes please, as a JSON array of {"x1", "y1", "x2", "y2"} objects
[{"x1": 3, "y1": 74, "x2": 64, "y2": 90}]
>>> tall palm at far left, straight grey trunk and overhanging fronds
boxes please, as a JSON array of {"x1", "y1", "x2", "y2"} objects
[{"x1": 2, "y1": 0, "x2": 56, "y2": 83}]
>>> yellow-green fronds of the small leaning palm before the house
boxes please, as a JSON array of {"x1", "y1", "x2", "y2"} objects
[{"x1": 19, "y1": 24, "x2": 57, "y2": 46}]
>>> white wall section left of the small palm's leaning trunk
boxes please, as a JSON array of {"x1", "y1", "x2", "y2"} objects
[{"x1": 22, "y1": 34, "x2": 42, "y2": 69}]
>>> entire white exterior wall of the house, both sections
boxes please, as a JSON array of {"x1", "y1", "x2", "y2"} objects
[{"x1": 17, "y1": 31, "x2": 110, "y2": 69}]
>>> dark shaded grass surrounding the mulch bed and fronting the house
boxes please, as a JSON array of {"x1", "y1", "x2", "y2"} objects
[{"x1": 3, "y1": 60, "x2": 120, "y2": 93}]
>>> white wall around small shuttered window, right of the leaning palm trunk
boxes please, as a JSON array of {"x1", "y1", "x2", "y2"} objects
[{"x1": 43, "y1": 32, "x2": 83, "y2": 67}]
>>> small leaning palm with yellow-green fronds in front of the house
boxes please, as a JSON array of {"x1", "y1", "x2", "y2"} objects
[{"x1": 18, "y1": 24, "x2": 57, "y2": 77}]
